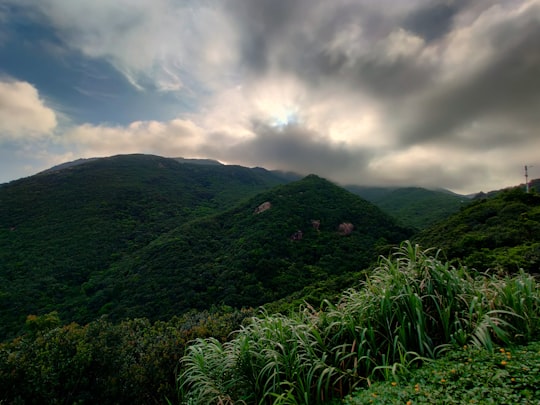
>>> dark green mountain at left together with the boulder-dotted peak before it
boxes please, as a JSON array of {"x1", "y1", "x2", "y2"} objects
[{"x1": 0, "y1": 155, "x2": 410, "y2": 339}]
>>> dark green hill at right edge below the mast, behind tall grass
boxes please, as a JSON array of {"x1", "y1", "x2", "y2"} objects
[{"x1": 416, "y1": 186, "x2": 540, "y2": 273}]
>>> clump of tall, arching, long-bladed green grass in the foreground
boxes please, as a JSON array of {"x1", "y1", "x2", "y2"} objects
[{"x1": 179, "y1": 242, "x2": 540, "y2": 404}]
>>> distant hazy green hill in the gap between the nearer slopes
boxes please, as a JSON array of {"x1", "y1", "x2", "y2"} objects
[{"x1": 346, "y1": 185, "x2": 470, "y2": 229}]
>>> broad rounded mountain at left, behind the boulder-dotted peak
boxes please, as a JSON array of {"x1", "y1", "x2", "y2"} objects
[{"x1": 0, "y1": 155, "x2": 292, "y2": 338}]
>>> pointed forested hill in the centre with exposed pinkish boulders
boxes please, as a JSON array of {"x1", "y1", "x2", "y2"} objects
[{"x1": 78, "y1": 175, "x2": 410, "y2": 319}]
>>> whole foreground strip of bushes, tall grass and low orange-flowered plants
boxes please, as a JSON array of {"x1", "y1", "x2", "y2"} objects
[{"x1": 0, "y1": 243, "x2": 540, "y2": 405}]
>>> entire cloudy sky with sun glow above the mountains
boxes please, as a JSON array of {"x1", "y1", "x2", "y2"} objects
[{"x1": 0, "y1": 0, "x2": 540, "y2": 194}]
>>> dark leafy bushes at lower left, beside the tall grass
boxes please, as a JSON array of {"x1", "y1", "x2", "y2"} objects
[{"x1": 0, "y1": 308, "x2": 252, "y2": 405}]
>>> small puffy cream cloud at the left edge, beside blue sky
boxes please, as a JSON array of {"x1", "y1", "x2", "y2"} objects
[{"x1": 0, "y1": 81, "x2": 57, "y2": 140}]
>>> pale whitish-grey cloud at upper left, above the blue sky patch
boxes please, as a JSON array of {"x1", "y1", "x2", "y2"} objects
[{"x1": 13, "y1": 0, "x2": 235, "y2": 92}]
